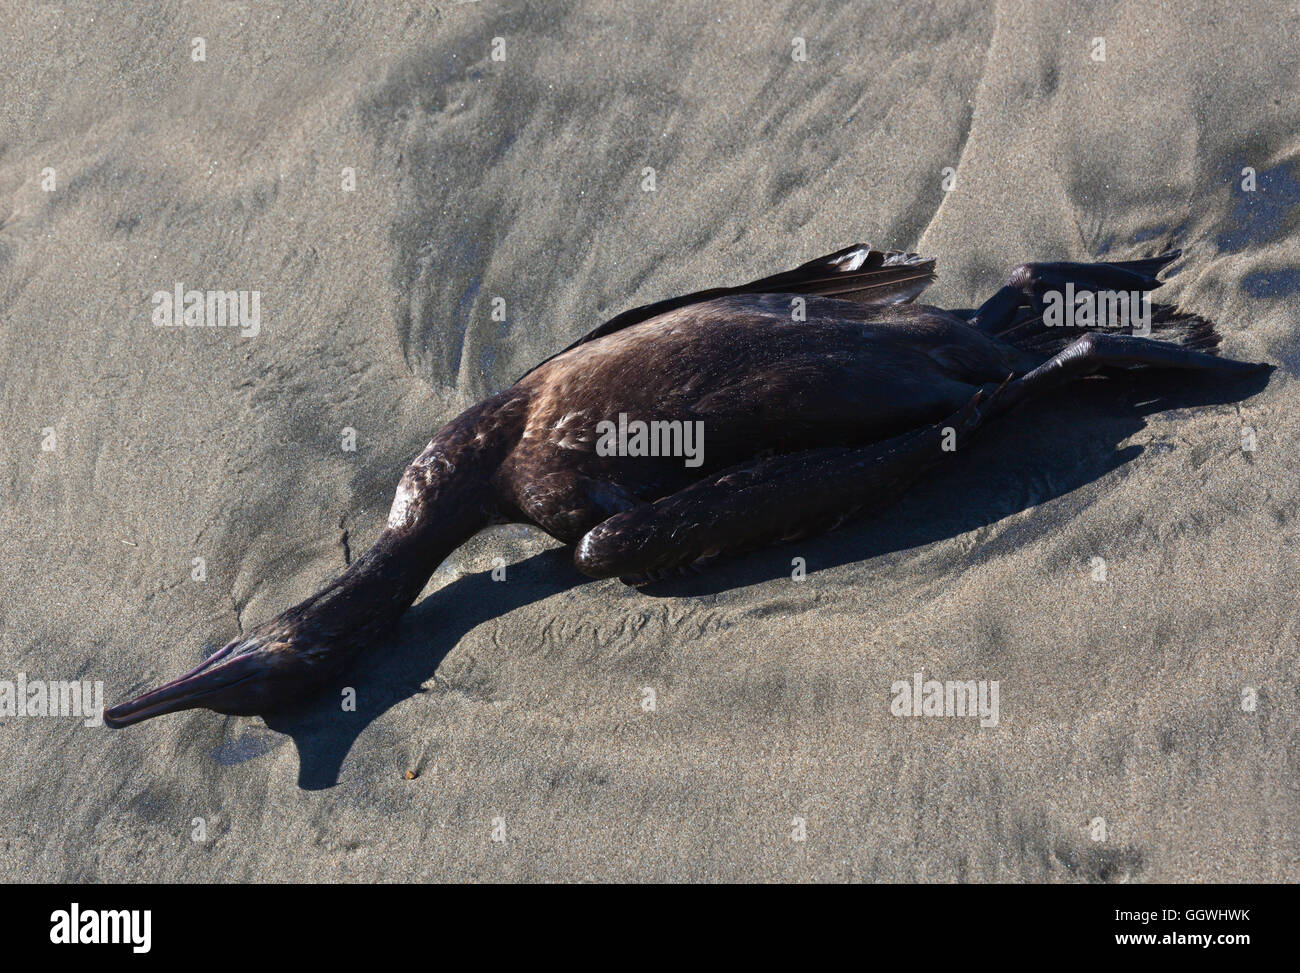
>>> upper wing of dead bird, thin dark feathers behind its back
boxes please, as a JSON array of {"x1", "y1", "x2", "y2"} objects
[{"x1": 520, "y1": 243, "x2": 937, "y2": 379}]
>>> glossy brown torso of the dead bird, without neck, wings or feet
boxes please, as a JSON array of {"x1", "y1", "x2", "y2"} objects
[{"x1": 486, "y1": 294, "x2": 1027, "y2": 542}]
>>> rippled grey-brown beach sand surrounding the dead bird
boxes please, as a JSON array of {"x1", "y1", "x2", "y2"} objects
[{"x1": 0, "y1": 0, "x2": 1300, "y2": 882}]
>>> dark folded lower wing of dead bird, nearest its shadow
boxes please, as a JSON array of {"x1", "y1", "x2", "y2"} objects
[{"x1": 573, "y1": 384, "x2": 1005, "y2": 580}]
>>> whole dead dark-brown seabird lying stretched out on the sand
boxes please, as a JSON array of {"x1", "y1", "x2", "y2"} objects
[{"x1": 105, "y1": 246, "x2": 1255, "y2": 726}]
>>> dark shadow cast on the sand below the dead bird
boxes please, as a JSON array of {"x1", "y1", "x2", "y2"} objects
[{"x1": 265, "y1": 373, "x2": 1268, "y2": 790}]
